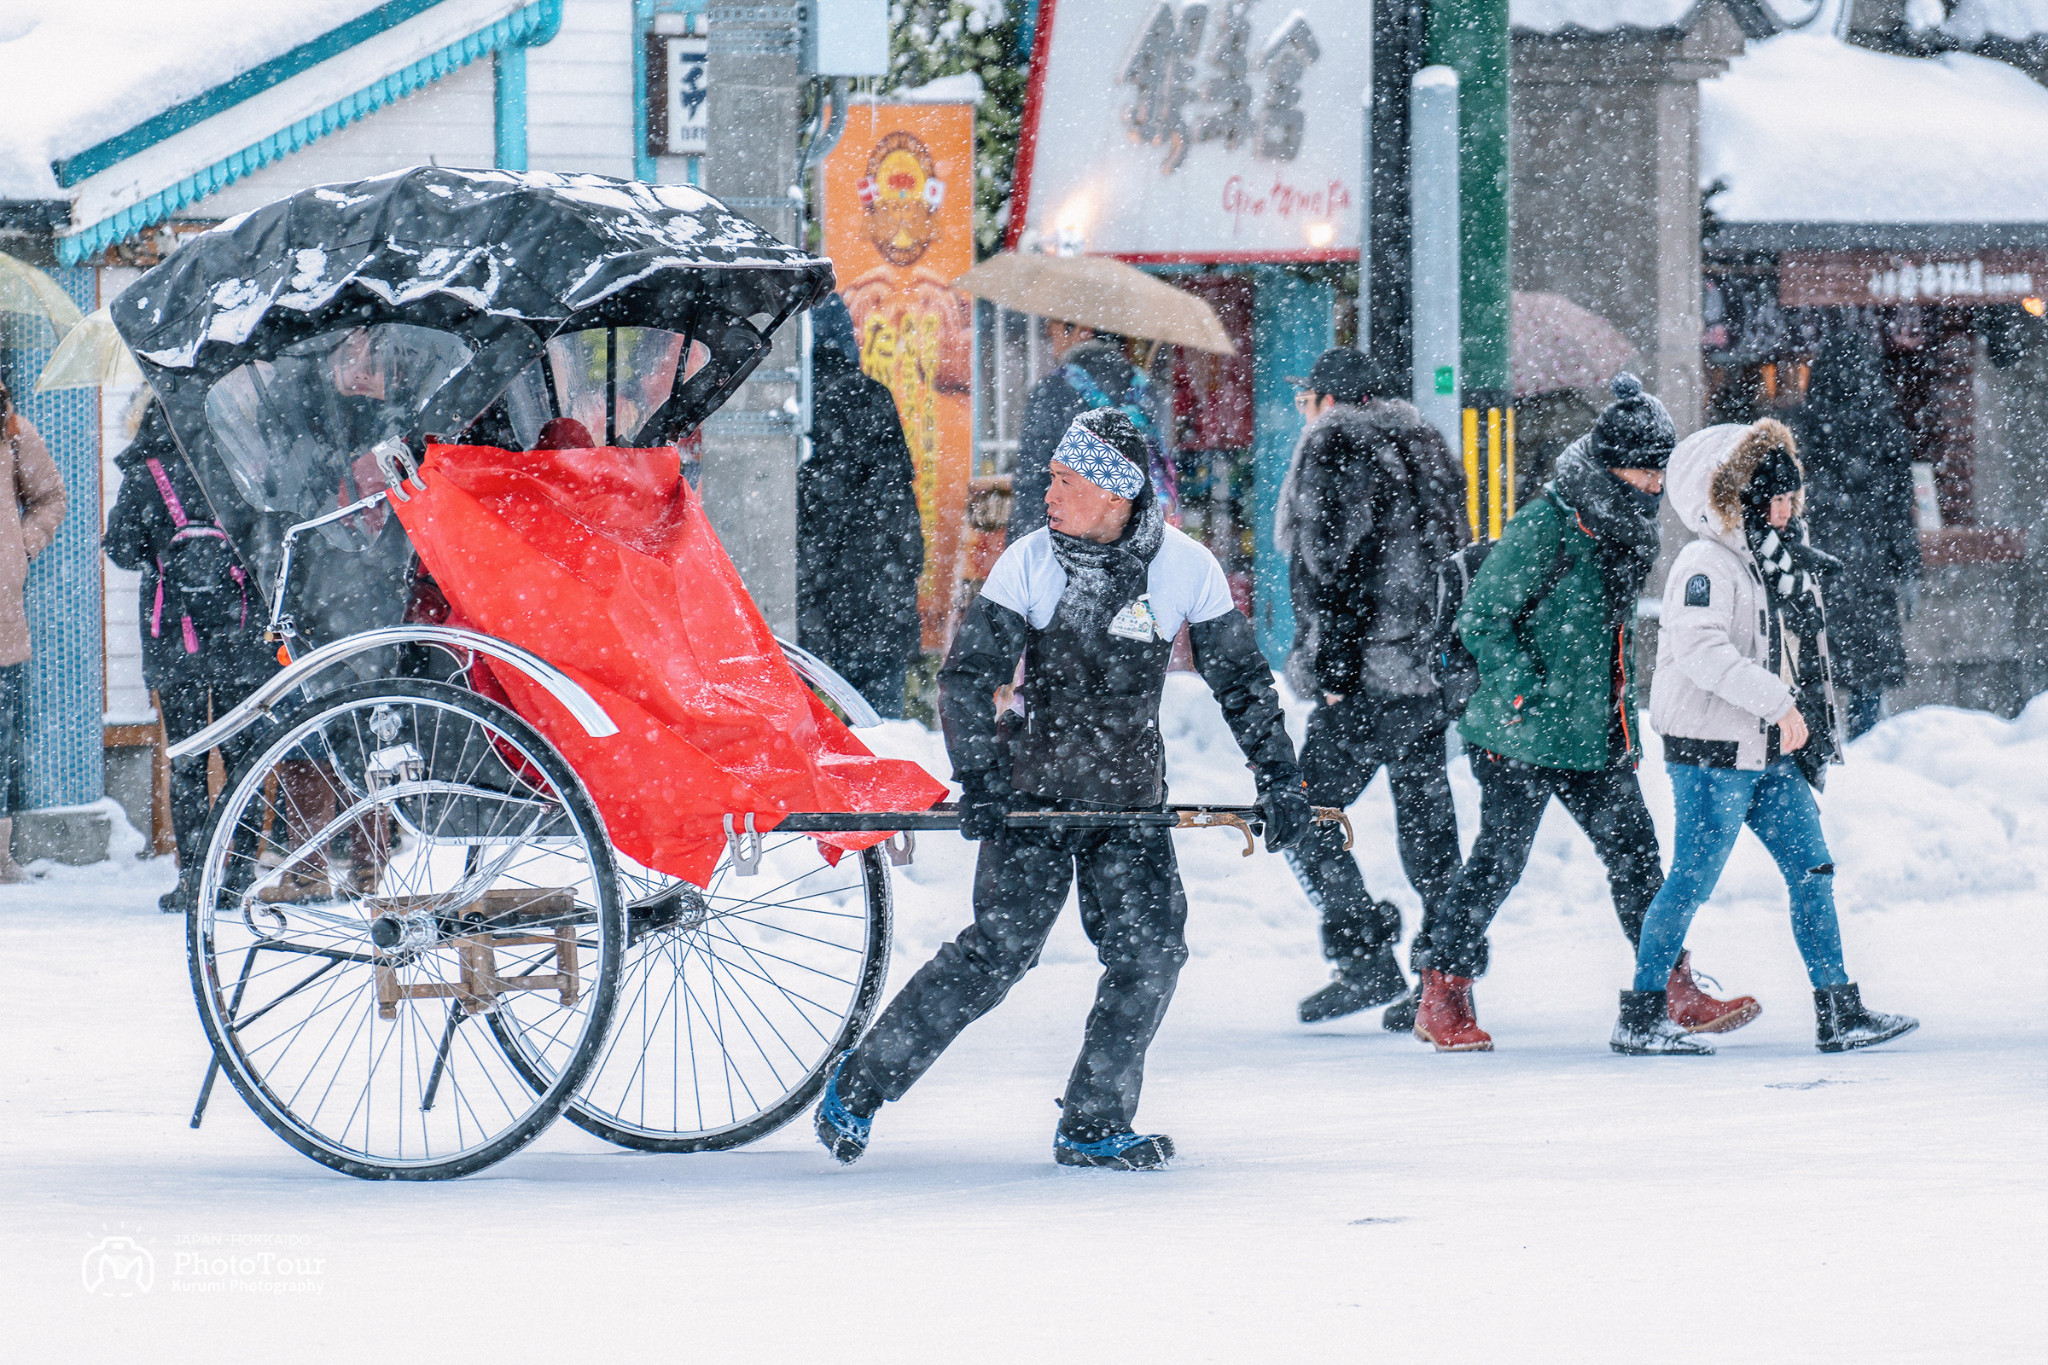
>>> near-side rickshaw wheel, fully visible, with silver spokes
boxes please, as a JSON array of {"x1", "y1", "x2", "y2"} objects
[{"x1": 186, "y1": 679, "x2": 625, "y2": 1181}]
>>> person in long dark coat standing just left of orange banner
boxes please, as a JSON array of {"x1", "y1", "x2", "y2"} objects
[{"x1": 797, "y1": 295, "x2": 924, "y2": 718}]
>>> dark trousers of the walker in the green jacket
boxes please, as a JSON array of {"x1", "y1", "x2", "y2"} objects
[{"x1": 1423, "y1": 749, "x2": 1663, "y2": 976}]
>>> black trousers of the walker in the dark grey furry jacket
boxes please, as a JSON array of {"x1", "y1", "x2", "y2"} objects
[{"x1": 1286, "y1": 698, "x2": 1458, "y2": 968}]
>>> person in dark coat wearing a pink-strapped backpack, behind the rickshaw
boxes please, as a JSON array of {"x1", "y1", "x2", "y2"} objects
[{"x1": 104, "y1": 403, "x2": 276, "y2": 915}]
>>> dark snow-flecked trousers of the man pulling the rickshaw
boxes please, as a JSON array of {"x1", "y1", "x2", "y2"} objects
[{"x1": 842, "y1": 829, "x2": 1188, "y2": 1142}]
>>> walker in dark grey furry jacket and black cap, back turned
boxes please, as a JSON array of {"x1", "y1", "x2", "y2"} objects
[{"x1": 1274, "y1": 346, "x2": 1464, "y2": 1029}]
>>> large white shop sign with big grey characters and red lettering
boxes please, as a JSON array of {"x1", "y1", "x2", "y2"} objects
[{"x1": 1012, "y1": 0, "x2": 1372, "y2": 260}]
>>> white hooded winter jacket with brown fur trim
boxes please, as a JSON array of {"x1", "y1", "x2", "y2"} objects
[{"x1": 1651, "y1": 420, "x2": 1796, "y2": 769}]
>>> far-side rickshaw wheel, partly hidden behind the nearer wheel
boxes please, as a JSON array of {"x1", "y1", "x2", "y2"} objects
[{"x1": 502, "y1": 833, "x2": 891, "y2": 1152}]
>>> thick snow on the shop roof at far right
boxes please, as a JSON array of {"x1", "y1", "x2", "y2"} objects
[{"x1": 1700, "y1": 33, "x2": 2048, "y2": 223}]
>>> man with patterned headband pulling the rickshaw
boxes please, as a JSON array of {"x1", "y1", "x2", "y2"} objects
[{"x1": 817, "y1": 407, "x2": 1313, "y2": 1171}]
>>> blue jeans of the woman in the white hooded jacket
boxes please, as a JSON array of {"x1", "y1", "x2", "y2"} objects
[{"x1": 1636, "y1": 759, "x2": 1849, "y2": 990}]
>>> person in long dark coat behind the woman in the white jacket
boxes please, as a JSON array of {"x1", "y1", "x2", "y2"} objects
[{"x1": 1788, "y1": 325, "x2": 1921, "y2": 739}]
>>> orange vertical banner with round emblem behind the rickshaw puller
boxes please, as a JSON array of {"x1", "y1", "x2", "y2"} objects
[{"x1": 823, "y1": 104, "x2": 975, "y2": 649}]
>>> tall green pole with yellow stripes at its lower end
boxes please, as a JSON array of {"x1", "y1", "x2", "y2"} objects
[{"x1": 1430, "y1": 0, "x2": 1516, "y2": 538}]
